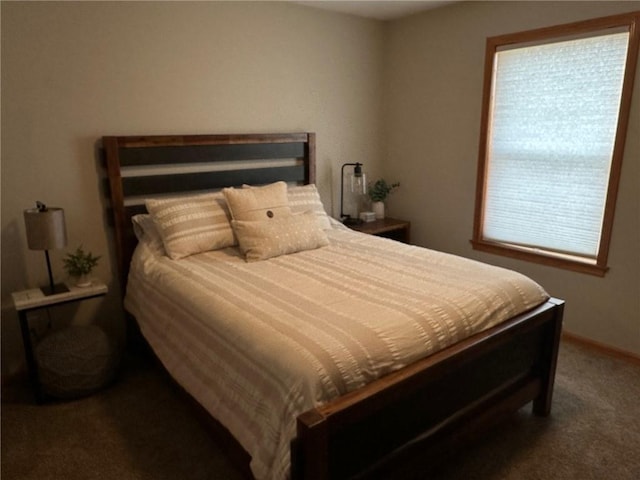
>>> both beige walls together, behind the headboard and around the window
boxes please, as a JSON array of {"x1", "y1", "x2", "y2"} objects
[{"x1": 1, "y1": 2, "x2": 640, "y2": 375}]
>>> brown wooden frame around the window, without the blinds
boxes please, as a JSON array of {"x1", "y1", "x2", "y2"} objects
[{"x1": 471, "y1": 11, "x2": 640, "y2": 276}]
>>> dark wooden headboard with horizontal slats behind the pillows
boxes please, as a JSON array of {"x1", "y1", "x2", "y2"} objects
[{"x1": 102, "y1": 133, "x2": 315, "y2": 288}]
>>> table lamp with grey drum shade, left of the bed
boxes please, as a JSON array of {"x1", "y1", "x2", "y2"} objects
[{"x1": 24, "y1": 202, "x2": 69, "y2": 295}]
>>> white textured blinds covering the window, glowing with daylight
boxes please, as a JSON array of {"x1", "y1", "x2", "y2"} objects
[{"x1": 482, "y1": 31, "x2": 629, "y2": 259}]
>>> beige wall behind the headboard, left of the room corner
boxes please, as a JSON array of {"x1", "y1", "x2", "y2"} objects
[{"x1": 1, "y1": 2, "x2": 383, "y2": 374}]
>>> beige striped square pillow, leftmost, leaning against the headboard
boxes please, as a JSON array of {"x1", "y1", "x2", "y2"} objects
[{"x1": 145, "y1": 192, "x2": 236, "y2": 260}]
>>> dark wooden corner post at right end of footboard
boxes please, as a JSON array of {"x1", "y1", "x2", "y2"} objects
[{"x1": 533, "y1": 298, "x2": 564, "y2": 417}]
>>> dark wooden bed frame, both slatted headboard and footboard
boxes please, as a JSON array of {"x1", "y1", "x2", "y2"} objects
[{"x1": 103, "y1": 133, "x2": 564, "y2": 479}]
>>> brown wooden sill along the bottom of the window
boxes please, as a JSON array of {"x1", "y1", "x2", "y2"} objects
[{"x1": 471, "y1": 240, "x2": 609, "y2": 277}]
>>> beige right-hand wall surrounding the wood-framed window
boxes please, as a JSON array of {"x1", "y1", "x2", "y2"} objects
[{"x1": 385, "y1": 2, "x2": 640, "y2": 354}]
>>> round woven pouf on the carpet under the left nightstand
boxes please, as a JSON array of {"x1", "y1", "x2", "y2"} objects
[{"x1": 36, "y1": 325, "x2": 116, "y2": 399}]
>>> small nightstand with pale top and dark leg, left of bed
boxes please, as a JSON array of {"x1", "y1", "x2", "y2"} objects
[{"x1": 11, "y1": 282, "x2": 107, "y2": 403}]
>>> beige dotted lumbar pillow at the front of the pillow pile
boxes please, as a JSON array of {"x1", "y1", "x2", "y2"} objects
[{"x1": 231, "y1": 212, "x2": 329, "y2": 262}]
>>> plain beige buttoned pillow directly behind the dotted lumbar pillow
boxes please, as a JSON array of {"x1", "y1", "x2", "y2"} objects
[{"x1": 222, "y1": 182, "x2": 291, "y2": 221}]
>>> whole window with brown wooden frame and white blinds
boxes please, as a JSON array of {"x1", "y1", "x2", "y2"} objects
[{"x1": 472, "y1": 12, "x2": 640, "y2": 276}]
